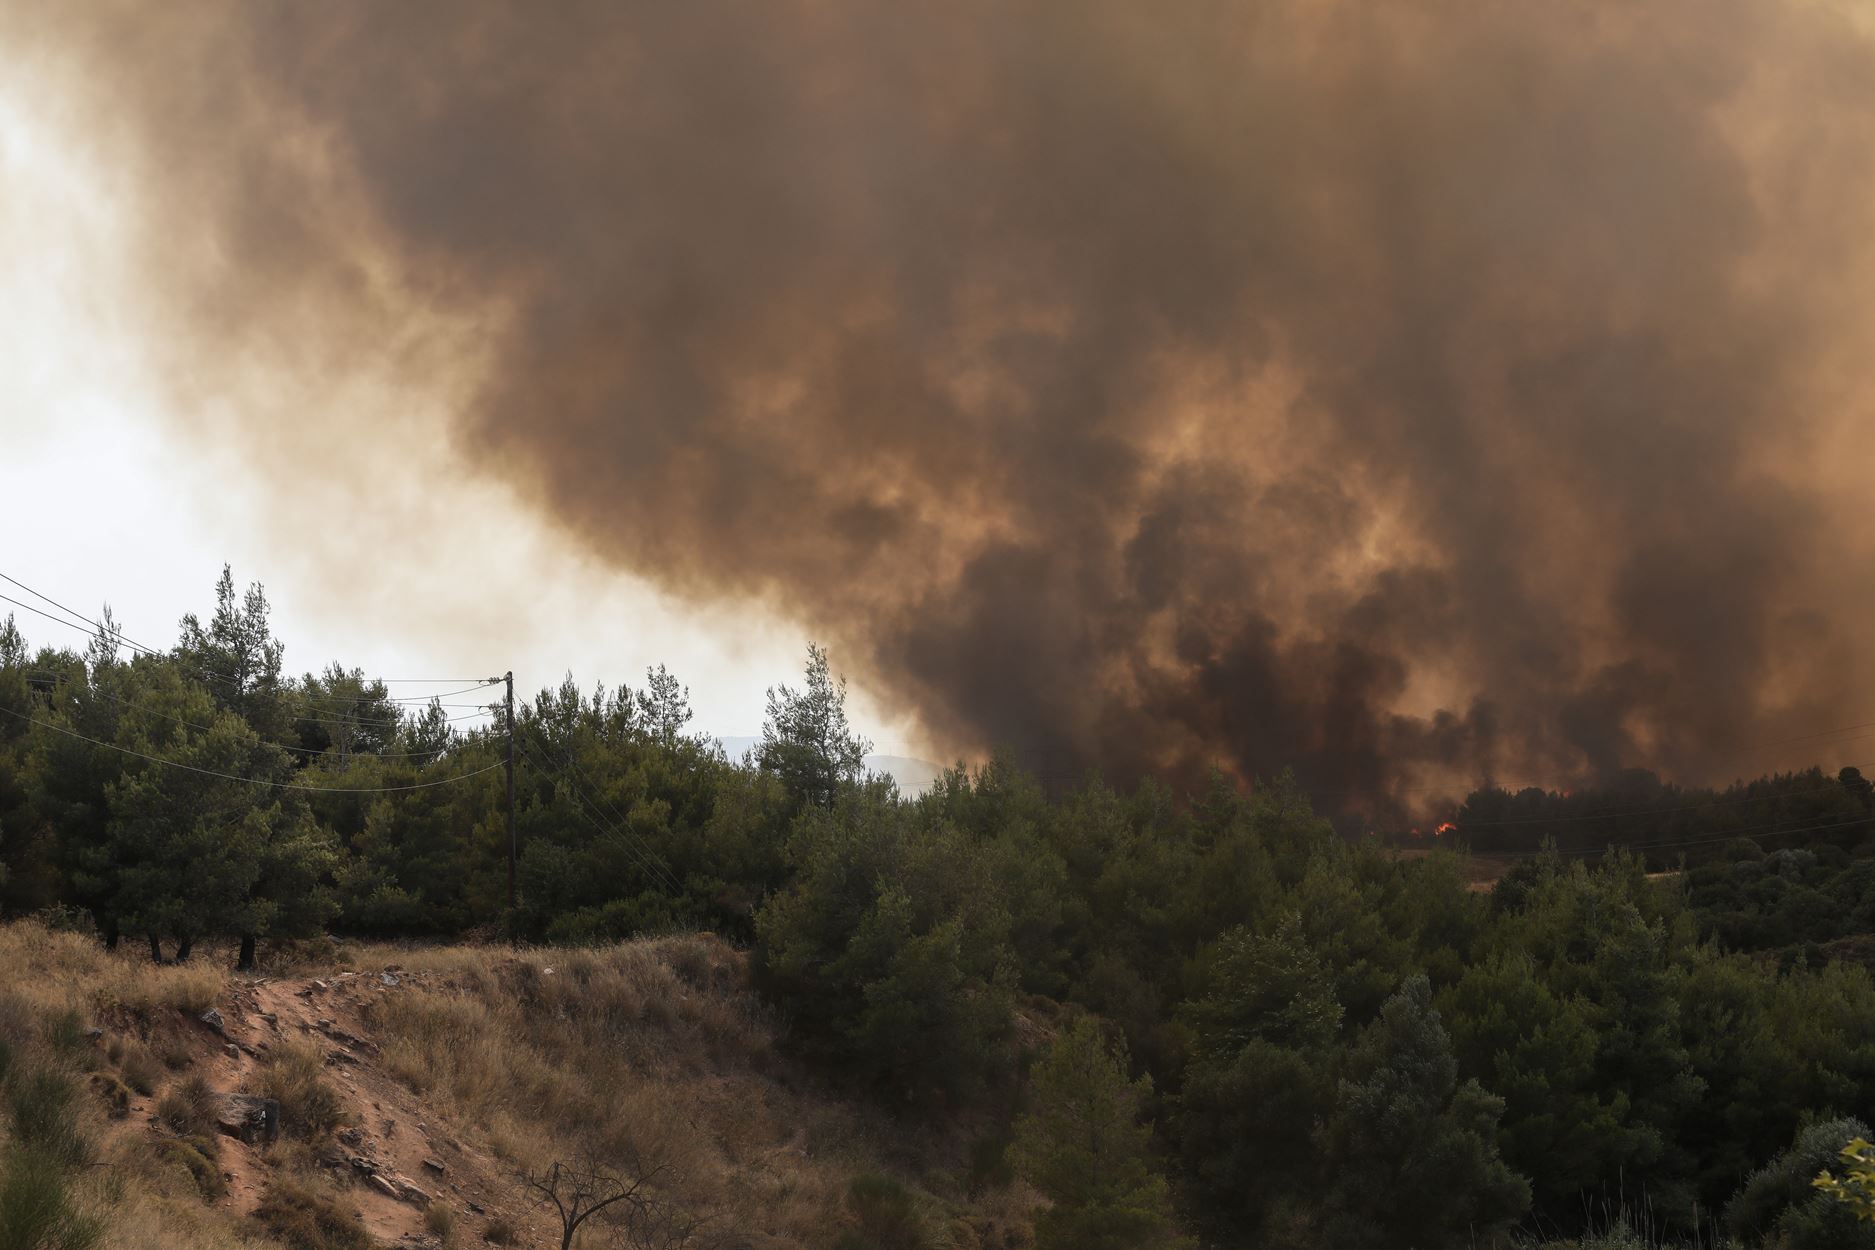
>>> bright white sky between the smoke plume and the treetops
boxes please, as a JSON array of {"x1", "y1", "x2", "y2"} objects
[{"x1": 0, "y1": 66, "x2": 915, "y2": 753}]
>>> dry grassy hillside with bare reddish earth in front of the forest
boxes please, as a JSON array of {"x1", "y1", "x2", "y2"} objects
[{"x1": 0, "y1": 922, "x2": 1031, "y2": 1250}]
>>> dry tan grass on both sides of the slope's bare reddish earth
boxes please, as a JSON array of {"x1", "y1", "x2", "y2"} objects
[{"x1": 0, "y1": 922, "x2": 1035, "y2": 1250}]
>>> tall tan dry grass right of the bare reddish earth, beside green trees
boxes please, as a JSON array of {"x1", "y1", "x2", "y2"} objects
[{"x1": 356, "y1": 937, "x2": 1031, "y2": 1250}]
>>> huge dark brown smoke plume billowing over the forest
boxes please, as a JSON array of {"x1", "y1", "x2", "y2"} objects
[{"x1": 22, "y1": 0, "x2": 1875, "y2": 819}]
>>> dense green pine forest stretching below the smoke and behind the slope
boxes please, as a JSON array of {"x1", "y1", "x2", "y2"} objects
[{"x1": 0, "y1": 573, "x2": 1875, "y2": 1250}]
